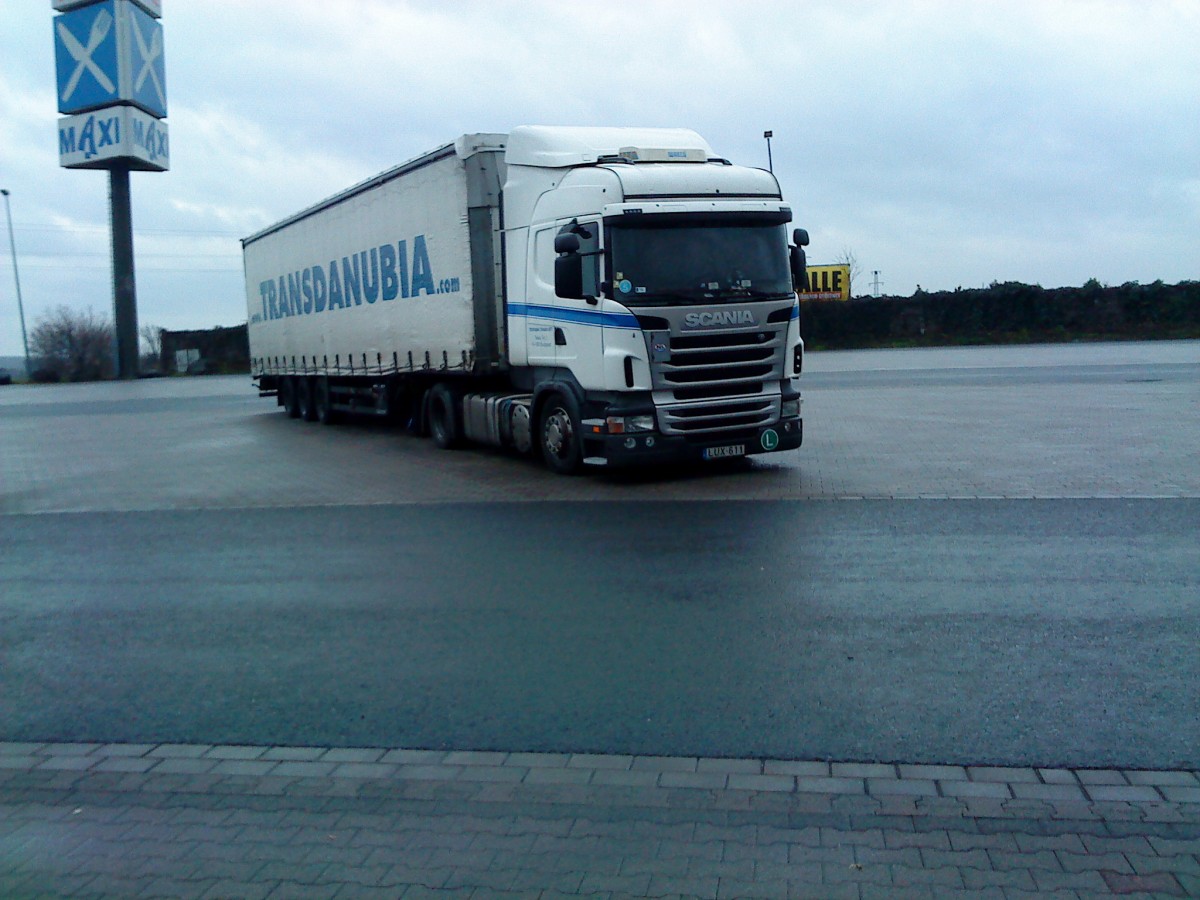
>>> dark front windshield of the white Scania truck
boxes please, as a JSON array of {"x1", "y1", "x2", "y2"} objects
[{"x1": 608, "y1": 216, "x2": 792, "y2": 306}]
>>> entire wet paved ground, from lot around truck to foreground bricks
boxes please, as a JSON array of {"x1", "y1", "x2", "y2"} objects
[{"x1": 0, "y1": 342, "x2": 1200, "y2": 900}]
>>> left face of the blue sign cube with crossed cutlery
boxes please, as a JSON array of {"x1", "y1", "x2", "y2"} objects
[{"x1": 54, "y1": 0, "x2": 121, "y2": 114}]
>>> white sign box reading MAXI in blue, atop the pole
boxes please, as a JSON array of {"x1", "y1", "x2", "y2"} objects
[{"x1": 59, "y1": 106, "x2": 170, "y2": 172}]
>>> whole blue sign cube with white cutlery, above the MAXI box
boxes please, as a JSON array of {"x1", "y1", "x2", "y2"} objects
[{"x1": 54, "y1": 0, "x2": 167, "y2": 119}]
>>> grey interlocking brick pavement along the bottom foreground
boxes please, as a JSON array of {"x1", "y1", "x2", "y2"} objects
[{"x1": 0, "y1": 743, "x2": 1200, "y2": 900}]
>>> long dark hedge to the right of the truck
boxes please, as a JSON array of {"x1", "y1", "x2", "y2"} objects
[{"x1": 800, "y1": 278, "x2": 1200, "y2": 349}]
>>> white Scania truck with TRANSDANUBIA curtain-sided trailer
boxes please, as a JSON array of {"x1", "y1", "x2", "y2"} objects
[{"x1": 242, "y1": 126, "x2": 808, "y2": 474}]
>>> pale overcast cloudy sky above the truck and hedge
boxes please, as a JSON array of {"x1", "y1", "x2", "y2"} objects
[{"x1": 0, "y1": 0, "x2": 1200, "y2": 355}]
